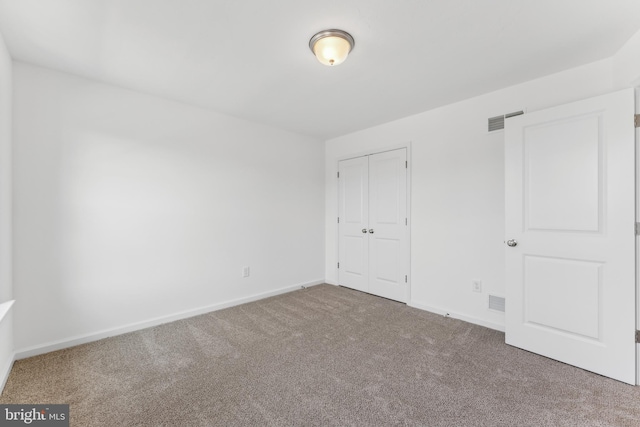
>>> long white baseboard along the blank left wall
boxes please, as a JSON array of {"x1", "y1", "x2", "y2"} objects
[{"x1": 15, "y1": 280, "x2": 325, "y2": 362}]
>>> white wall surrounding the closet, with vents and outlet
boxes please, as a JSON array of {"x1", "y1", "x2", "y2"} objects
[{"x1": 325, "y1": 60, "x2": 612, "y2": 329}]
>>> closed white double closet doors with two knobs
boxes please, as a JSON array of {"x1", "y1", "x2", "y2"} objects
[{"x1": 338, "y1": 148, "x2": 409, "y2": 302}]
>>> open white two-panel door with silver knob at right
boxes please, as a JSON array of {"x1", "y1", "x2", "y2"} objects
[{"x1": 505, "y1": 89, "x2": 636, "y2": 384}]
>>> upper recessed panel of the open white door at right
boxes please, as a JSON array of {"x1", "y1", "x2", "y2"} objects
[{"x1": 524, "y1": 114, "x2": 604, "y2": 232}]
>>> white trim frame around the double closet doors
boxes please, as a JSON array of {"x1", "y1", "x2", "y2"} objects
[{"x1": 333, "y1": 141, "x2": 413, "y2": 305}]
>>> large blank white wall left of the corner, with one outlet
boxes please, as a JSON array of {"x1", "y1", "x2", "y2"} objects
[{"x1": 13, "y1": 63, "x2": 324, "y2": 356}]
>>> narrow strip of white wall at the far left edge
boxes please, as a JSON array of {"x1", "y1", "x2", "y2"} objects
[{"x1": 0, "y1": 29, "x2": 13, "y2": 391}]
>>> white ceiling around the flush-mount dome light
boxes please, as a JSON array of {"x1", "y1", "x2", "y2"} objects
[{"x1": 0, "y1": 0, "x2": 640, "y2": 138}]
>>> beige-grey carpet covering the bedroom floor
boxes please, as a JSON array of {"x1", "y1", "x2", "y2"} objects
[{"x1": 0, "y1": 285, "x2": 640, "y2": 426}]
